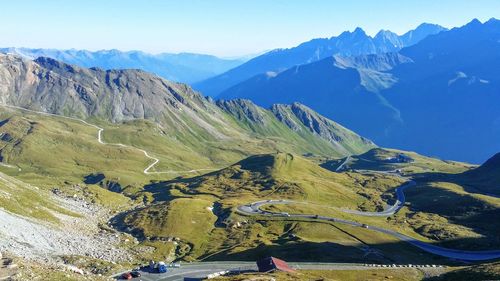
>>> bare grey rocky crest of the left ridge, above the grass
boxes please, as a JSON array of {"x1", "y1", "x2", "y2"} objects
[{"x1": 0, "y1": 55, "x2": 223, "y2": 125}]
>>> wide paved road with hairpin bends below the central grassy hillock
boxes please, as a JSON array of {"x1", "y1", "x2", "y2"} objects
[{"x1": 237, "y1": 181, "x2": 500, "y2": 261}]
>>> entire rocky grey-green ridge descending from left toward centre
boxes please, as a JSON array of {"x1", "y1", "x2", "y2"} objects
[{"x1": 0, "y1": 54, "x2": 374, "y2": 159}]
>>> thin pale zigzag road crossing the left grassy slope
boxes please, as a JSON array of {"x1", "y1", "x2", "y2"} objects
[{"x1": 0, "y1": 104, "x2": 216, "y2": 175}]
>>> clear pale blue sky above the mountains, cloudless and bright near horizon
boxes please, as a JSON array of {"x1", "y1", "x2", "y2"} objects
[{"x1": 0, "y1": 0, "x2": 500, "y2": 56}]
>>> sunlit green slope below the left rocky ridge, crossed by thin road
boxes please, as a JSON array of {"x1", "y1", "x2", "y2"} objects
[{"x1": 0, "y1": 103, "x2": 376, "y2": 190}]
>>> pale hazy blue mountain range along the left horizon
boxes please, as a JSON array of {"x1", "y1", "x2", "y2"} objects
[{"x1": 0, "y1": 48, "x2": 246, "y2": 83}]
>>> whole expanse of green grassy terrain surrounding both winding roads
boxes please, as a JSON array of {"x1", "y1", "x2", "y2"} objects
[{"x1": 0, "y1": 104, "x2": 500, "y2": 262}]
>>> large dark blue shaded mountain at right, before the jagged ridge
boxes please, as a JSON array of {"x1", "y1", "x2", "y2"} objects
[{"x1": 219, "y1": 19, "x2": 500, "y2": 163}]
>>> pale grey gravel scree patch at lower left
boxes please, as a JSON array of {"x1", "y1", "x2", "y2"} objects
[{"x1": 0, "y1": 191, "x2": 130, "y2": 264}]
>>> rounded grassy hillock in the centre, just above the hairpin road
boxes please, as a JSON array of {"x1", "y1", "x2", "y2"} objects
[{"x1": 150, "y1": 153, "x2": 402, "y2": 207}]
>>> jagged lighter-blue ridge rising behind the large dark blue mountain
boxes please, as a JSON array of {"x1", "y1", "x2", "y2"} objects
[{"x1": 193, "y1": 23, "x2": 445, "y2": 96}]
